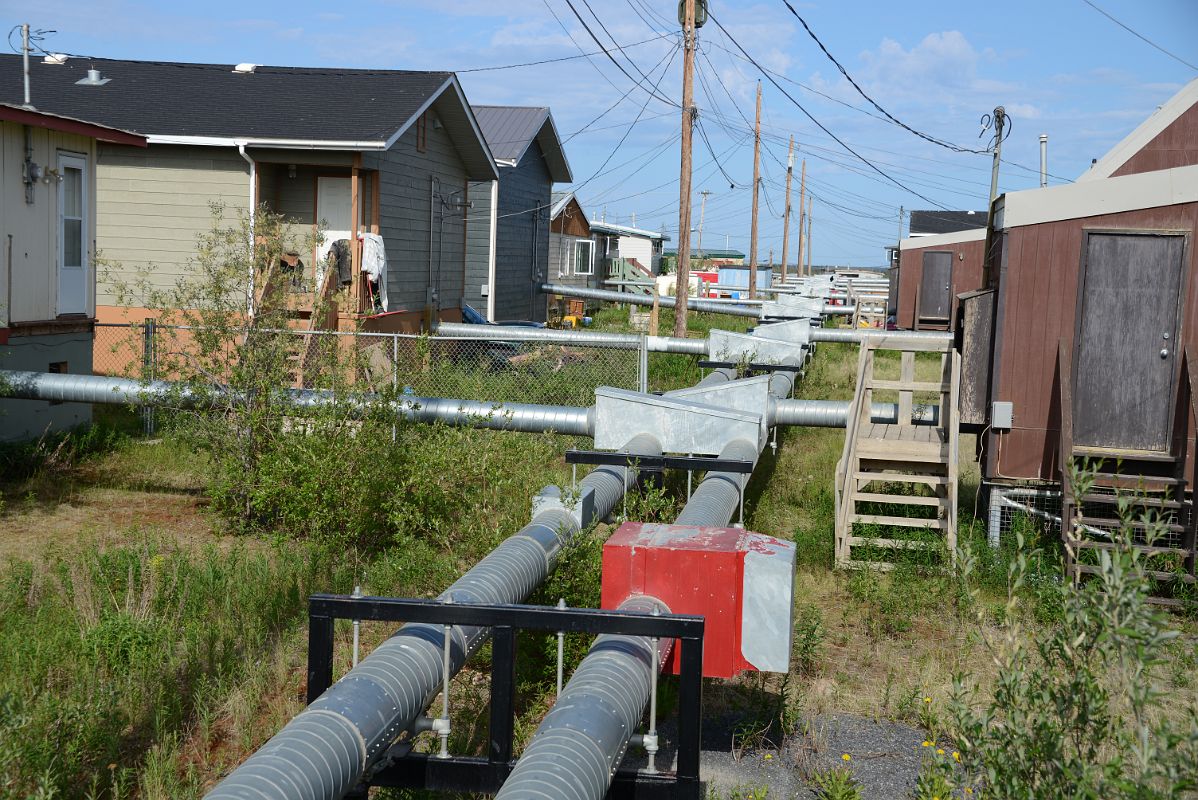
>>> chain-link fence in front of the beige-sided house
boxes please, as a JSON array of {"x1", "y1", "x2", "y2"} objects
[{"x1": 92, "y1": 321, "x2": 648, "y2": 406}]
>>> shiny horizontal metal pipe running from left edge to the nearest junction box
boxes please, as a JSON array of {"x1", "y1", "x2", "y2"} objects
[{"x1": 0, "y1": 370, "x2": 594, "y2": 436}]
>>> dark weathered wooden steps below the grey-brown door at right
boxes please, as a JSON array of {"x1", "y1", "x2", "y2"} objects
[{"x1": 1057, "y1": 339, "x2": 1198, "y2": 605}]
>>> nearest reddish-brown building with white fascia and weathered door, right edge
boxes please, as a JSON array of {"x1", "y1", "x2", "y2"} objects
[{"x1": 984, "y1": 74, "x2": 1198, "y2": 480}]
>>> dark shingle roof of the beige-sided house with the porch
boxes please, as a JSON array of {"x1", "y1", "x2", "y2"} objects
[{"x1": 0, "y1": 54, "x2": 495, "y2": 180}]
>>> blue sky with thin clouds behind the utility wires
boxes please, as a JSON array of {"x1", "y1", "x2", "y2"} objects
[{"x1": 7, "y1": 0, "x2": 1198, "y2": 266}]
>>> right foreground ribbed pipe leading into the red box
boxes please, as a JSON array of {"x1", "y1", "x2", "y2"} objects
[{"x1": 496, "y1": 596, "x2": 671, "y2": 800}]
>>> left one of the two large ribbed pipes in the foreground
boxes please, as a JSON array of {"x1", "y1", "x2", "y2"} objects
[{"x1": 206, "y1": 434, "x2": 661, "y2": 800}]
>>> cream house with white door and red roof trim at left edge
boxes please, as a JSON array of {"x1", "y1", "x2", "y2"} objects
[{"x1": 0, "y1": 100, "x2": 146, "y2": 440}]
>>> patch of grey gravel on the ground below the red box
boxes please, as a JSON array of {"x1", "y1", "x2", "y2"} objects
[{"x1": 624, "y1": 714, "x2": 926, "y2": 800}]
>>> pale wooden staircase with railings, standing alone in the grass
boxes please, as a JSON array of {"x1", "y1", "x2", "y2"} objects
[{"x1": 836, "y1": 335, "x2": 961, "y2": 570}]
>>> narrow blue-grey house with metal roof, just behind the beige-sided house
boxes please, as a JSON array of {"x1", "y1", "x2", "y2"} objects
[{"x1": 462, "y1": 105, "x2": 573, "y2": 322}]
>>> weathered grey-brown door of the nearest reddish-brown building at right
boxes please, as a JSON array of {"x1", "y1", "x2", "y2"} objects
[{"x1": 1073, "y1": 232, "x2": 1186, "y2": 451}]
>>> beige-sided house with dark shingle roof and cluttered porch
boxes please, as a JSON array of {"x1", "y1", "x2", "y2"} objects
[{"x1": 0, "y1": 55, "x2": 496, "y2": 331}]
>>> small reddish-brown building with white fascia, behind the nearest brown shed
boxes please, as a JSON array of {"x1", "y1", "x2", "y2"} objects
[{"x1": 890, "y1": 211, "x2": 986, "y2": 329}]
